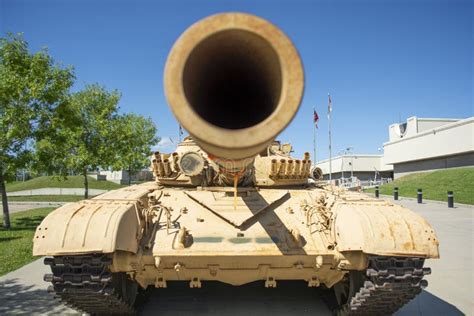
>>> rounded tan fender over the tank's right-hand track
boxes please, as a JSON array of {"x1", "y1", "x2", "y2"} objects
[{"x1": 334, "y1": 200, "x2": 439, "y2": 258}]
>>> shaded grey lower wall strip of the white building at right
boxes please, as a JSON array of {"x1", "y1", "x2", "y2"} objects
[{"x1": 393, "y1": 152, "x2": 474, "y2": 179}]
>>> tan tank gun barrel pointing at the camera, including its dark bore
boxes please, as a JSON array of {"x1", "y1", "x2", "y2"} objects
[{"x1": 164, "y1": 13, "x2": 304, "y2": 172}]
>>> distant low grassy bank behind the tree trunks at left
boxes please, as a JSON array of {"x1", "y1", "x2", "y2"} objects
[{"x1": 7, "y1": 176, "x2": 123, "y2": 192}]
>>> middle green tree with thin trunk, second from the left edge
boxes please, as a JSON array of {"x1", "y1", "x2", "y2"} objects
[{"x1": 37, "y1": 84, "x2": 120, "y2": 198}]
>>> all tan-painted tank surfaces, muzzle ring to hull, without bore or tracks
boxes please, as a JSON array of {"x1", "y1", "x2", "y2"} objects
[{"x1": 33, "y1": 13, "x2": 439, "y2": 287}]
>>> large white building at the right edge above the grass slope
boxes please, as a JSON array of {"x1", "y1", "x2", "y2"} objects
[{"x1": 384, "y1": 116, "x2": 474, "y2": 178}]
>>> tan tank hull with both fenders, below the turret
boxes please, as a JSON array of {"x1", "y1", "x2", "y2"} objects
[{"x1": 34, "y1": 183, "x2": 439, "y2": 288}]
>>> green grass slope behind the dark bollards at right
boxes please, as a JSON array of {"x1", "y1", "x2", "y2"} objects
[{"x1": 365, "y1": 167, "x2": 474, "y2": 204}]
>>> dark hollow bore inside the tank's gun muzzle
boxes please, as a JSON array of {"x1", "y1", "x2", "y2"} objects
[{"x1": 183, "y1": 30, "x2": 282, "y2": 129}]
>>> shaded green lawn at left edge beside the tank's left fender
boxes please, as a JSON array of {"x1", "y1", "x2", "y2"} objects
[{"x1": 0, "y1": 207, "x2": 54, "y2": 275}]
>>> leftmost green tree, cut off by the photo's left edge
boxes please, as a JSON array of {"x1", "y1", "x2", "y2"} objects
[{"x1": 0, "y1": 34, "x2": 74, "y2": 228}]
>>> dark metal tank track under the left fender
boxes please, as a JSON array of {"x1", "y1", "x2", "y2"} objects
[{"x1": 44, "y1": 254, "x2": 135, "y2": 315}]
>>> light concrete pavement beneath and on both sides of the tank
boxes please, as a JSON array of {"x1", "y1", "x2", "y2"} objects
[{"x1": 0, "y1": 199, "x2": 474, "y2": 316}]
